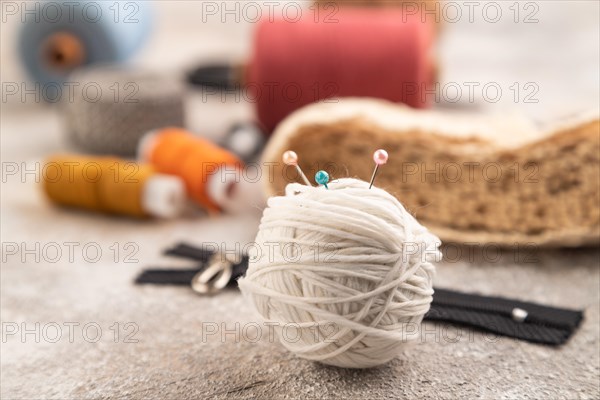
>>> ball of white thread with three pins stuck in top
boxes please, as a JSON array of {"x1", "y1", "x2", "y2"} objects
[{"x1": 239, "y1": 179, "x2": 440, "y2": 368}]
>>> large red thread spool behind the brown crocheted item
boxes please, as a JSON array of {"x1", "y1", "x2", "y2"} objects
[{"x1": 246, "y1": 7, "x2": 435, "y2": 131}]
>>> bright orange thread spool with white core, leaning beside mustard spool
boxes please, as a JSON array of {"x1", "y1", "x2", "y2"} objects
[{"x1": 138, "y1": 128, "x2": 243, "y2": 211}]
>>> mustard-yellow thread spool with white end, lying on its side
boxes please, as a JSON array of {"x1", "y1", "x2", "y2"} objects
[{"x1": 42, "y1": 155, "x2": 185, "y2": 218}]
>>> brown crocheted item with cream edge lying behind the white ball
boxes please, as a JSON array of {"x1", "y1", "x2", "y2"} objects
[{"x1": 263, "y1": 98, "x2": 600, "y2": 247}]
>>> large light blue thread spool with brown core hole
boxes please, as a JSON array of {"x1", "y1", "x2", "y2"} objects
[{"x1": 19, "y1": 0, "x2": 151, "y2": 101}]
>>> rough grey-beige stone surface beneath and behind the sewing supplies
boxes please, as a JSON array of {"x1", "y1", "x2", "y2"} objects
[{"x1": 0, "y1": 1, "x2": 600, "y2": 399}]
